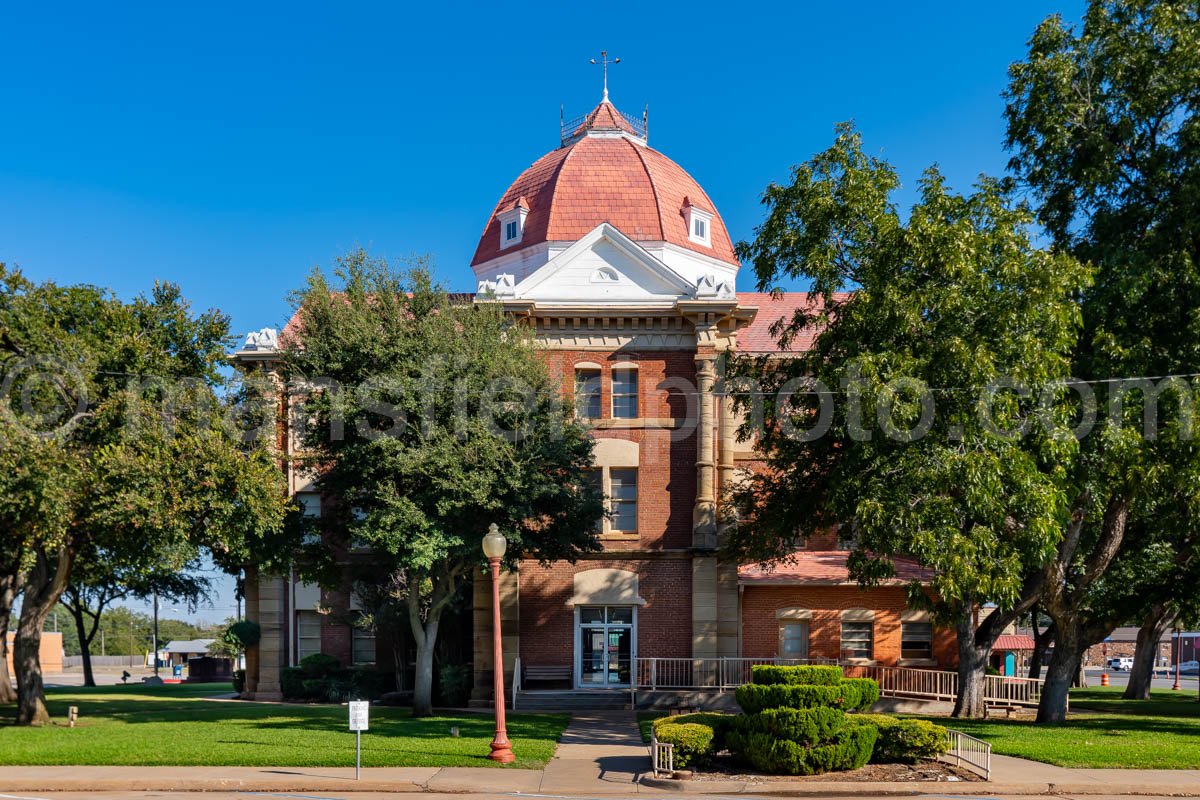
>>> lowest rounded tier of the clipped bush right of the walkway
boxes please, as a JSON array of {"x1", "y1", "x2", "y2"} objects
[{"x1": 728, "y1": 724, "x2": 878, "y2": 775}]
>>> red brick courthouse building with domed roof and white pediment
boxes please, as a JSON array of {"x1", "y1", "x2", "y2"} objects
[{"x1": 236, "y1": 96, "x2": 954, "y2": 699}]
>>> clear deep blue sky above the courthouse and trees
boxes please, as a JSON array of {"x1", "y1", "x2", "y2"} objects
[{"x1": 0, "y1": 0, "x2": 1082, "y2": 618}]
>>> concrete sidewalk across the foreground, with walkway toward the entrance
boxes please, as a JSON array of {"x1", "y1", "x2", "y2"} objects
[{"x1": 7, "y1": 711, "x2": 1200, "y2": 798}]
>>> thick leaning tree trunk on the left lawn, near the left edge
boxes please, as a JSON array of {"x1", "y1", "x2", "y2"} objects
[{"x1": 12, "y1": 547, "x2": 74, "y2": 726}]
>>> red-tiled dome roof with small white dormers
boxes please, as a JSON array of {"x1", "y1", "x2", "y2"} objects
[{"x1": 472, "y1": 101, "x2": 738, "y2": 266}]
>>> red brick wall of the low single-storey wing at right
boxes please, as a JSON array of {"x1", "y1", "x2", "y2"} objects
[{"x1": 742, "y1": 587, "x2": 955, "y2": 666}]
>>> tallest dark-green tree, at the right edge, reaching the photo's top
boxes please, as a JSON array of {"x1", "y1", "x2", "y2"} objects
[{"x1": 1006, "y1": 0, "x2": 1200, "y2": 722}]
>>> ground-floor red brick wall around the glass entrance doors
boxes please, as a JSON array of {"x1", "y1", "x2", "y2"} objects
[{"x1": 521, "y1": 559, "x2": 691, "y2": 666}]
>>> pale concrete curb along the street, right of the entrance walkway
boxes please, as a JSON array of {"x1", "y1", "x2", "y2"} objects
[{"x1": 640, "y1": 776, "x2": 1196, "y2": 798}]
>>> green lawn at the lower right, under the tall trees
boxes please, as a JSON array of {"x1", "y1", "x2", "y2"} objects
[{"x1": 934, "y1": 687, "x2": 1200, "y2": 769}]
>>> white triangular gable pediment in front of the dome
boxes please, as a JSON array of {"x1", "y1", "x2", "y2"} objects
[{"x1": 514, "y1": 223, "x2": 695, "y2": 302}]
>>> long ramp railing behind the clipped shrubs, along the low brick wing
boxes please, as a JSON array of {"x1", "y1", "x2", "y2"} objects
[{"x1": 630, "y1": 658, "x2": 1043, "y2": 706}]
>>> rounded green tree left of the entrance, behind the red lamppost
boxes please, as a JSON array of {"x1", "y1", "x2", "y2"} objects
[{"x1": 284, "y1": 251, "x2": 602, "y2": 715}]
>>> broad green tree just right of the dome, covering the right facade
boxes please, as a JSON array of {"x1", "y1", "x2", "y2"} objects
[{"x1": 726, "y1": 125, "x2": 1087, "y2": 716}]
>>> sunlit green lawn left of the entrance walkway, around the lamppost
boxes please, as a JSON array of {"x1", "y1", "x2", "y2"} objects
[{"x1": 0, "y1": 684, "x2": 570, "y2": 769}]
